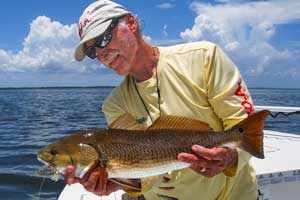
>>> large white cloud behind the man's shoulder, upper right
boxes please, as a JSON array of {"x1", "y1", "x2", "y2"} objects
[{"x1": 180, "y1": 0, "x2": 300, "y2": 79}]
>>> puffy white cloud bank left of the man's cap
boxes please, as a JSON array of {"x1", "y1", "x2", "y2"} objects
[{"x1": 0, "y1": 16, "x2": 101, "y2": 73}]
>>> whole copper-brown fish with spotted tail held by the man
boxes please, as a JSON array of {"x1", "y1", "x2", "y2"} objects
[{"x1": 37, "y1": 110, "x2": 269, "y2": 186}]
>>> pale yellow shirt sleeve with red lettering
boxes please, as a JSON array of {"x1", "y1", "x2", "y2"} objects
[{"x1": 206, "y1": 45, "x2": 254, "y2": 174}]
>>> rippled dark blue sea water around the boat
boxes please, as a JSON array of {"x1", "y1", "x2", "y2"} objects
[{"x1": 0, "y1": 87, "x2": 300, "y2": 200}]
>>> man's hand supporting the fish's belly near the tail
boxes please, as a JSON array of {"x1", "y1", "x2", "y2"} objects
[{"x1": 177, "y1": 145, "x2": 238, "y2": 177}]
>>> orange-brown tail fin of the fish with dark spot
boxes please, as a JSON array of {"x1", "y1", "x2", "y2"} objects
[{"x1": 234, "y1": 110, "x2": 270, "y2": 158}]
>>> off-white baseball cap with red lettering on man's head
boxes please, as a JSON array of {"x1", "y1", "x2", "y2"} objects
[{"x1": 74, "y1": 0, "x2": 130, "y2": 61}]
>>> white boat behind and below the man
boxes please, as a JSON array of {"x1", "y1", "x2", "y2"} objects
[{"x1": 58, "y1": 106, "x2": 300, "y2": 200}]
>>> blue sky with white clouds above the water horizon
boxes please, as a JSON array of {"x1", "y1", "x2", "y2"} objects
[{"x1": 0, "y1": 0, "x2": 300, "y2": 88}]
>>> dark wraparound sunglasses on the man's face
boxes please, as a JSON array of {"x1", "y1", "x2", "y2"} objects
[{"x1": 83, "y1": 18, "x2": 120, "y2": 59}]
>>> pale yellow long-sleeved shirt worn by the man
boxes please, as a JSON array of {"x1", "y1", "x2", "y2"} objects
[{"x1": 102, "y1": 42, "x2": 257, "y2": 200}]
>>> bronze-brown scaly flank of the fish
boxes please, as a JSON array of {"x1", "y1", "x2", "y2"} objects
[{"x1": 95, "y1": 130, "x2": 241, "y2": 167}]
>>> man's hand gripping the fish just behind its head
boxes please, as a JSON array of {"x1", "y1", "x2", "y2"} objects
[{"x1": 64, "y1": 166, "x2": 126, "y2": 196}]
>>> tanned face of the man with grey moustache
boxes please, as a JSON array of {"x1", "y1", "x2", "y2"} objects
[{"x1": 85, "y1": 18, "x2": 137, "y2": 75}]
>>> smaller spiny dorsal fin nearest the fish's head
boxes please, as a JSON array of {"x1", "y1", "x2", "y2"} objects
[{"x1": 108, "y1": 113, "x2": 145, "y2": 130}]
